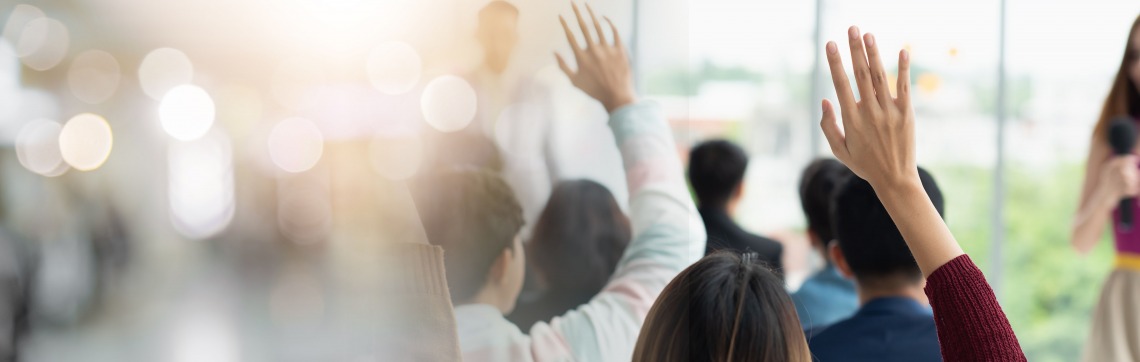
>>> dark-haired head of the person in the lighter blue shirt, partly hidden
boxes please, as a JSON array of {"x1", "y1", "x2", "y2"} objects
[{"x1": 799, "y1": 158, "x2": 854, "y2": 246}]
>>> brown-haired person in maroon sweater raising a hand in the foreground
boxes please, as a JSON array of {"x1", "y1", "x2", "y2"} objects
[{"x1": 633, "y1": 26, "x2": 1026, "y2": 362}]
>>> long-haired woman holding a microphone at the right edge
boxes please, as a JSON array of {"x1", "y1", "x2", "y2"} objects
[{"x1": 1070, "y1": 17, "x2": 1140, "y2": 362}]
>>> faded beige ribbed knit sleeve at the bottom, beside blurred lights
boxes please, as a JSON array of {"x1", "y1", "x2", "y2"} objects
[{"x1": 382, "y1": 244, "x2": 462, "y2": 361}]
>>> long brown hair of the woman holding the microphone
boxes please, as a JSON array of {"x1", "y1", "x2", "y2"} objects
[{"x1": 1092, "y1": 17, "x2": 1140, "y2": 138}]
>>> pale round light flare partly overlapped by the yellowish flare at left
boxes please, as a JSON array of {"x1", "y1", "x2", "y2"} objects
[{"x1": 16, "y1": 120, "x2": 67, "y2": 176}]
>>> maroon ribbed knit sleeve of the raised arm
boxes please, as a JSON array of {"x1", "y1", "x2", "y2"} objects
[{"x1": 926, "y1": 255, "x2": 1025, "y2": 362}]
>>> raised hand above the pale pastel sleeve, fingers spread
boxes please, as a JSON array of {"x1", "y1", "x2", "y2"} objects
[{"x1": 554, "y1": 3, "x2": 637, "y2": 113}]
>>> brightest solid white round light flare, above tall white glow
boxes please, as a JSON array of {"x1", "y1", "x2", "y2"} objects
[{"x1": 158, "y1": 84, "x2": 217, "y2": 141}]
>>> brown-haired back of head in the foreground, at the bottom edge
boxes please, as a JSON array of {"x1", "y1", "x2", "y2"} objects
[{"x1": 633, "y1": 252, "x2": 811, "y2": 362}]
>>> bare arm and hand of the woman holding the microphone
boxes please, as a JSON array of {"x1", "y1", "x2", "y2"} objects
[{"x1": 1069, "y1": 138, "x2": 1140, "y2": 254}]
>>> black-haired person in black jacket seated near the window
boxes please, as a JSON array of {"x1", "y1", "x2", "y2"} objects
[{"x1": 689, "y1": 140, "x2": 783, "y2": 275}]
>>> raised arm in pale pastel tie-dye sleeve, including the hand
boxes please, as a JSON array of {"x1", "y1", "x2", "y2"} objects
[{"x1": 531, "y1": 6, "x2": 705, "y2": 361}]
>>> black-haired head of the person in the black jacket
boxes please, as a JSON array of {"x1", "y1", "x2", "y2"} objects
[{"x1": 689, "y1": 140, "x2": 748, "y2": 207}]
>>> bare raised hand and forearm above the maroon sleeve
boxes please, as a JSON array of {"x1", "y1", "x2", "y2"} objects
[{"x1": 820, "y1": 26, "x2": 963, "y2": 275}]
